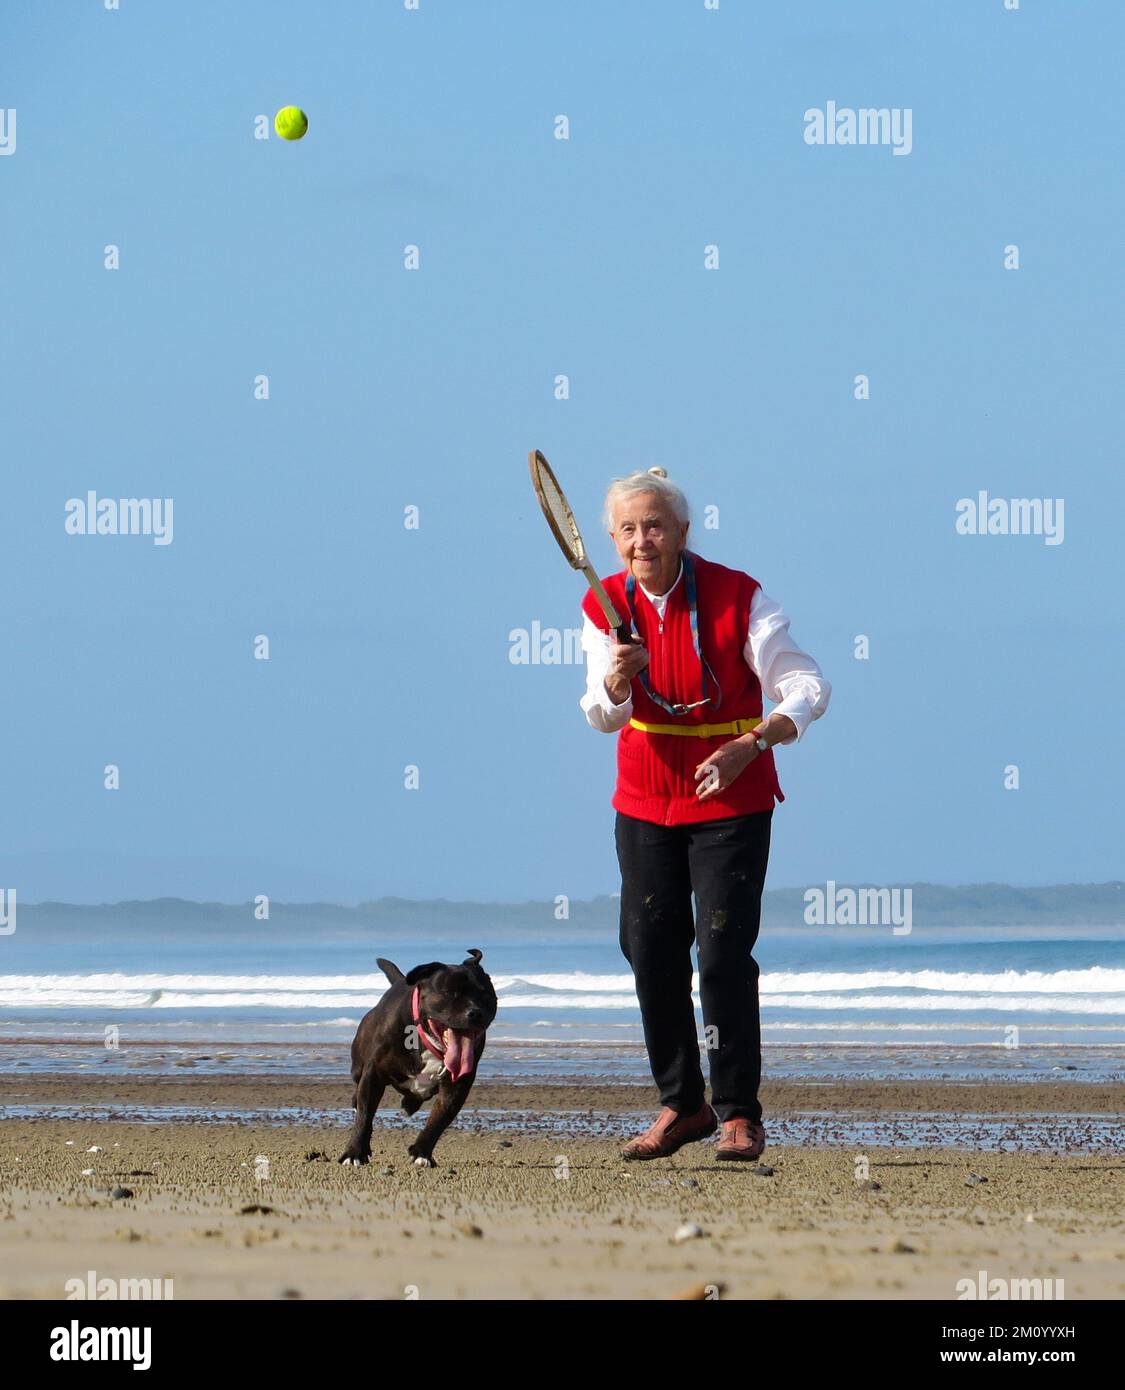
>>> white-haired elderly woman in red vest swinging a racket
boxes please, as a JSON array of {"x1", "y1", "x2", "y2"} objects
[{"x1": 580, "y1": 468, "x2": 830, "y2": 1159}]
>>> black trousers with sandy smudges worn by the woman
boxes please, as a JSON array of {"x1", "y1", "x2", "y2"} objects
[{"x1": 615, "y1": 810, "x2": 773, "y2": 1122}]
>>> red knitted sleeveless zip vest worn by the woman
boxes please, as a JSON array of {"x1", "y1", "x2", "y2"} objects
[{"x1": 583, "y1": 550, "x2": 786, "y2": 826}]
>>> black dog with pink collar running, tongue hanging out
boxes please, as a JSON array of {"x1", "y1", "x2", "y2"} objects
[{"x1": 339, "y1": 951, "x2": 496, "y2": 1168}]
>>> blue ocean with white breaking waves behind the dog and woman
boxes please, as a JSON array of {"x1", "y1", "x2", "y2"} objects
[{"x1": 0, "y1": 904, "x2": 1125, "y2": 1083}]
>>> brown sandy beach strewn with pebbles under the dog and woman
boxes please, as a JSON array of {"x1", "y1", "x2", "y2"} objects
[{"x1": 0, "y1": 1074, "x2": 1125, "y2": 1300}]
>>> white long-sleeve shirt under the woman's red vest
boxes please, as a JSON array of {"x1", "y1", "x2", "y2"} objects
[{"x1": 578, "y1": 560, "x2": 832, "y2": 744}]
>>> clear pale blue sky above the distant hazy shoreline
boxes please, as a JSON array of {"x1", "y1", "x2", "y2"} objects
[{"x1": 0, "y1": 0, "x2": 1125, "y2": 902}]
